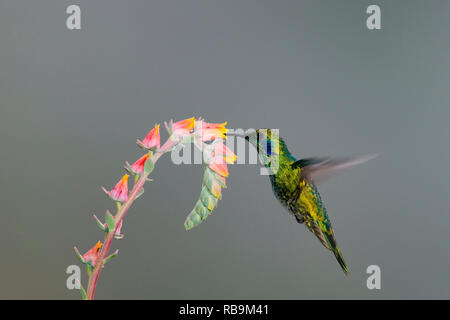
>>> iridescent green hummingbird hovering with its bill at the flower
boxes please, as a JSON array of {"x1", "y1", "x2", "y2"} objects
[{"x1": 230, "y1": 129, "x2": 377, "y2": 274}]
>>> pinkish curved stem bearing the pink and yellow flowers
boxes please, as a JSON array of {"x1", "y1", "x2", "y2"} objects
[{"x1": 87, "y1": 139, "x2": 178, "y2": 300}]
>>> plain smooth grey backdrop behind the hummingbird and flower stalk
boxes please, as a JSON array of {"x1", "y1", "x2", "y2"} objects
[{"x1": 0, "y1": 0, "x2": 450, "y2": 299}]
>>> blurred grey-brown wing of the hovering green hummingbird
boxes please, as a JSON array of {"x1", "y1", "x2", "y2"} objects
[{"x1": 292, "y1": 154, "x2": 379, "y2": 183}]
